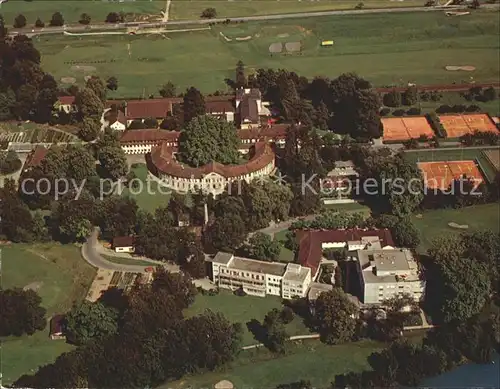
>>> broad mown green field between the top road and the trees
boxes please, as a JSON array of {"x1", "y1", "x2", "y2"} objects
[{"x1": 35, "y1": 11, "x2": 500, "y2": 97}]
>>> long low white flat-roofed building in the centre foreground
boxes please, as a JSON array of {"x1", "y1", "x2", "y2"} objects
[{"x1": 211, "y1": 252, "x2": 311, "y2": 299}]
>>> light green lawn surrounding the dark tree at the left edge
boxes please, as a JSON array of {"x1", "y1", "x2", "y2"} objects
[{"x1": 1, "y1": 244, "x2": 95, "y2": 384}]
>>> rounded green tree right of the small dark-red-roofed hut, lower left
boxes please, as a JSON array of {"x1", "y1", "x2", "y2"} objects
[{"x1": 65, "y1": 300, "x2": 118, "y2": 345}]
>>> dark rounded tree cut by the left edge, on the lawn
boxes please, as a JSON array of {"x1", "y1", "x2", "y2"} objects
[{"x1": 0, "y1": 288, "x2": 47, "y2": 336}]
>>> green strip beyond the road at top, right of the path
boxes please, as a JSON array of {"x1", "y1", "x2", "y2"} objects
[{"x1": 170, "y1": 0, "x2": 423, "y2": 19}]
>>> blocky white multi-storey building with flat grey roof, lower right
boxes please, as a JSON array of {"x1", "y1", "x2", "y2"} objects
[{"x1": 355, "y1": 248, "x2": 425, "y2": 304}]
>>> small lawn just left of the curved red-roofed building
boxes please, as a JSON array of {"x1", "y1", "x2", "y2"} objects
[{"x1": 122, "y1": 164, "x2": 170, "y2": 212}]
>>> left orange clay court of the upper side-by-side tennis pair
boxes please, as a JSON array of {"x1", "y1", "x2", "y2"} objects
[{"x1": 381, "y1": 116, "x2": 434, "y2": 141}]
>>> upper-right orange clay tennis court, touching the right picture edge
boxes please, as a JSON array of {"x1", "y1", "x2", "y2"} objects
[{"x1": 439, "y1": 113, "x2": 498, "y2": 138}]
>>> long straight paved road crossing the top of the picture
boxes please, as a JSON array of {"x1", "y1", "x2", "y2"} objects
[{"x1": 9, "y1": 4, "x2": 492, "y2": 35}]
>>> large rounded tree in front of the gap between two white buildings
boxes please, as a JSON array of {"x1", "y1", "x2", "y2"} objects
[{"x1": 314, "y1": 288, "x2": 358, "y2": 344}]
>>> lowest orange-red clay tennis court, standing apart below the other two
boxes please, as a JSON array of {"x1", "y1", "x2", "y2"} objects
[{"x1": 418, "y1": 161, "x2": 484, "y2": 190}]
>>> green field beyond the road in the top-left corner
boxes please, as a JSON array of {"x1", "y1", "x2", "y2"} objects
[{"x1": 0, "y1": 0, "x2": 162, "y2": 29}]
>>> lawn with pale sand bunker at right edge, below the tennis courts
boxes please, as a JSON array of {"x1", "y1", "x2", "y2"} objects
[{"x1": 413, "y1": 204, "x2": 500, "y2": 253}]
